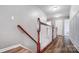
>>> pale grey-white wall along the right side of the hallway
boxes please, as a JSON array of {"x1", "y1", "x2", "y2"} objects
[{"x1": 70, "y1": 5, "x2": 79, "y2": 51}]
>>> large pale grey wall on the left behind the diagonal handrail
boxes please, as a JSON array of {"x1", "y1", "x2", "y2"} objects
[{"x1": 0, "y1": 6, "x2": 46, "y2": 52}]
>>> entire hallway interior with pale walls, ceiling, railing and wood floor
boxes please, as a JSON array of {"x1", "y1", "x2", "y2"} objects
[{"x1": 0, "y1": 5, "x2": 79, "y2": 53}]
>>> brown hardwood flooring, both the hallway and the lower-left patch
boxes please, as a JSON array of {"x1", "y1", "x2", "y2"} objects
[{"x1": 3, "y1": 36, "x2": 78, "y2": 53}]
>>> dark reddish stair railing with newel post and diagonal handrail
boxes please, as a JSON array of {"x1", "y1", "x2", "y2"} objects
[{"x1": 17, "y1": 18, "x2": 50, "y2": 53}]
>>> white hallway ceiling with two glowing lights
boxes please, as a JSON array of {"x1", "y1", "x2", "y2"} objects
[{"x1": 38, "y1": 5, "x2": 70, "y2": 21}]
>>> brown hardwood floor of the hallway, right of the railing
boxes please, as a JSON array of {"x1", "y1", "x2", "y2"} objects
[{"x1": 44, "y1": 36, "x2": 78, "y2": 53}]
